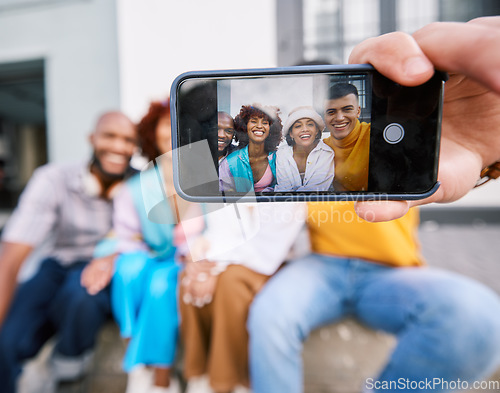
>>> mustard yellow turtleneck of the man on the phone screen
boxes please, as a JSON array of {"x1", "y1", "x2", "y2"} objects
[{"x1": 323, "y1": 120, "x2": 371, "y2": 191}]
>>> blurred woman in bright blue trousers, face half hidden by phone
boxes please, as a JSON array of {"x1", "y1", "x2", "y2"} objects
[{"x1": 91, "y1": 101, "x2": 180, "y2": 393}]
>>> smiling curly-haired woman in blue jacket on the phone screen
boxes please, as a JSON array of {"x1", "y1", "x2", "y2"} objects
[{"x1": 219, "y1": 104, "x2": 282, "y2": 193}]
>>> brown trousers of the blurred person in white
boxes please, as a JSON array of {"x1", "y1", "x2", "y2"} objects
[{"x1": 179, "y1": 265, "x2": 269, "y2": 392}]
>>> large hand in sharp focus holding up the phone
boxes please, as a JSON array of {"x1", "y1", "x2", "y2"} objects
[{"x1": 349, "y1": 17, "x2": 500, "y2": 221}]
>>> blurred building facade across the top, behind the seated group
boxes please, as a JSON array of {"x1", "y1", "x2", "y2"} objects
[{"x1": 0, "y1": 0, "x2": 500, "y2": 208}]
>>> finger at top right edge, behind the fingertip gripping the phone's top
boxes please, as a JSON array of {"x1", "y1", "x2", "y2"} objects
[{"x1": 413, "y1": 17, "x2": 500, "y2": 93}]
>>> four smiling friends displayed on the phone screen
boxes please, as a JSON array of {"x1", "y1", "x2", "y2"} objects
[{"x1": 217, "y1": 82, "x2": 370, "y2": 193}]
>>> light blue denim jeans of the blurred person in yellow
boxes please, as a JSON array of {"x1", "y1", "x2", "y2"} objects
[{"x1": 248, "y1": 254, "x2": 500, "y2": 393}]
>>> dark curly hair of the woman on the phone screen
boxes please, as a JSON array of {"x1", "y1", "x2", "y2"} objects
[{"x1": 234, "y1": 105, "x2": 283, "y2": 153}]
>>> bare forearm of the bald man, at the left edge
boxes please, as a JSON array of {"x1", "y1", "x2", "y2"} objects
[{"x1": 0, "y1": 242, "x2": 33, "y2": 330}]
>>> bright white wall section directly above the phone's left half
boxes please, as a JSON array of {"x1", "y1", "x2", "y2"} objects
[{"x1": 118, "y1": 0, "x2": 276, "y2": 120}]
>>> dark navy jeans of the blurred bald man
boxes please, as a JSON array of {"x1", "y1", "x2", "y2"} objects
[{"x1": 0, "y1": 259, "x2": 110, "y2": 393}]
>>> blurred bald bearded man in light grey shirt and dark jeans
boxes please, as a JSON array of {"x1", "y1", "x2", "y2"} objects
[{"x1": 0, "y1": 112, "x2": 137, "y2": 393}]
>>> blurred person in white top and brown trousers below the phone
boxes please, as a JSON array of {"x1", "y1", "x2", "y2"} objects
[{"x1": 179, "y1": 203, "x2": 305, "y2": 393}]
